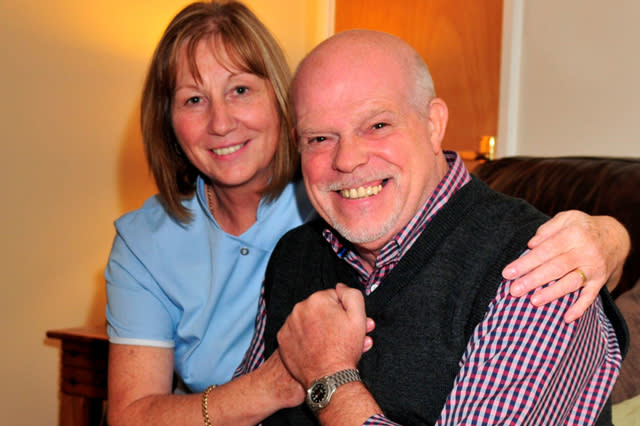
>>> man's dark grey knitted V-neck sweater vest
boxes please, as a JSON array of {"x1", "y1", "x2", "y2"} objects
[{"x1": 264, "y1": 178, "x2": 620, "y2": 426}]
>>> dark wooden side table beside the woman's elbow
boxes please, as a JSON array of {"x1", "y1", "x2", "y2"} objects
[{"x1": 47, "y1": 326, "x2": 109, "y2": 426}]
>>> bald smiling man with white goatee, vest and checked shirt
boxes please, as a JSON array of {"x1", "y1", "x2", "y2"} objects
[{"x1": 240, "y1": 31, "x2": 625, "y2": 425}]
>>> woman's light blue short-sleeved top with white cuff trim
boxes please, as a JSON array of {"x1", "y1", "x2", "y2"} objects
[{"x1": 105, "y1": 179, "x2": 313, "y2": 392}]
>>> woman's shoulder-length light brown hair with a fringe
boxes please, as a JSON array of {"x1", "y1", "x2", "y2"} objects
[{"x1": 141, "y1": 1, "x2": 299, "y2": 223}]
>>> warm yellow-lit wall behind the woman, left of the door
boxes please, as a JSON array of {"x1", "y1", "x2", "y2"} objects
[{"x1": 0, "y1": 0, "x2": 331, "y2": 426}]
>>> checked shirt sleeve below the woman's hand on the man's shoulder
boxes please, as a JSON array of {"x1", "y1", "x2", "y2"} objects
[{"x1": 437, "y1": 280, "x2": 622, "y2": 425}]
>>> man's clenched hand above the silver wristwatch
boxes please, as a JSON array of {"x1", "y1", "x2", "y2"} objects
[{"x1": 278, "y1": 284, "x2": 372, "y2": 388}]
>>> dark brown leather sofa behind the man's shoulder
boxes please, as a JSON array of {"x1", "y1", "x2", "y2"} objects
[{"x1": 473, "y1": 157, "x2": 640, "y2": 403}]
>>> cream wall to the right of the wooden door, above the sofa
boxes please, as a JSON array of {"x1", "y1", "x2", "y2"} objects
[{"x1": 516, "y1": 0, "x2": 640, "y2": 157}]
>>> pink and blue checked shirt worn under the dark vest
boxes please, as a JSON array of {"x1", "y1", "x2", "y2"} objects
[{"x1": 236, "y1": 151, "x2": 622, "y2": 426}]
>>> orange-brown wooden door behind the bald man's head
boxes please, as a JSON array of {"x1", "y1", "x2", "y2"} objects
[{"x1": 335, "y1": 0, "x2": 503, "y2": 165}]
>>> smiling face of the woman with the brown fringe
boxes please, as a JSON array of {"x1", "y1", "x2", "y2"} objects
[{"x1": 171, "y1": 40, "x2": 280, "y2": 191}]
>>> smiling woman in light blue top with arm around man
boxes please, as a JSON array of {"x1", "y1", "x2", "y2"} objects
[{"x1": 105, "y1": 2, "x2": 632, "y2": 425}]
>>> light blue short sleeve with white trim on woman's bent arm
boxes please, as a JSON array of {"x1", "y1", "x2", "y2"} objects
[{"x1": 105, "y1": 234, "x2": 174, "y2": 348}]
